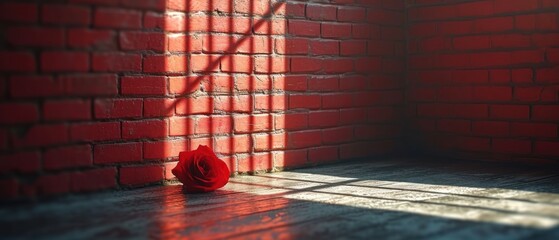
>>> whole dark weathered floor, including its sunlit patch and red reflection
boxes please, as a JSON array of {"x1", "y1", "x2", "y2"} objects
[{"x1": 0, "y1": 159, "x2": 559, "y2": 239}]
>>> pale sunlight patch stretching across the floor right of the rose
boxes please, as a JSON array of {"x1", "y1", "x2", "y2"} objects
[{"x1": 225, "y1": 172, "x2": 559, "y2": 229}]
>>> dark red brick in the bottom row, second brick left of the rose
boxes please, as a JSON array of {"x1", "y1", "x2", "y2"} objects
[{"x1": 71, "y1": 168, "x2": 117, "y2": 192}]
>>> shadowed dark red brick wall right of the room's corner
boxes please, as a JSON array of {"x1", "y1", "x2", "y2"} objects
[{"x1": 407, "y1": 0, "x2": 559, "y2": 163}]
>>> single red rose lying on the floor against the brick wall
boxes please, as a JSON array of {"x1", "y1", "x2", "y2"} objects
[{"x1": 172, "y1": 145, "x2": 230, "y2": 193}]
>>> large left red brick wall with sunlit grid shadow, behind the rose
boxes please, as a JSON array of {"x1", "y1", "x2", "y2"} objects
[{"x1": 0, "y1": 0, "x2": 405, "y2": 199}]
